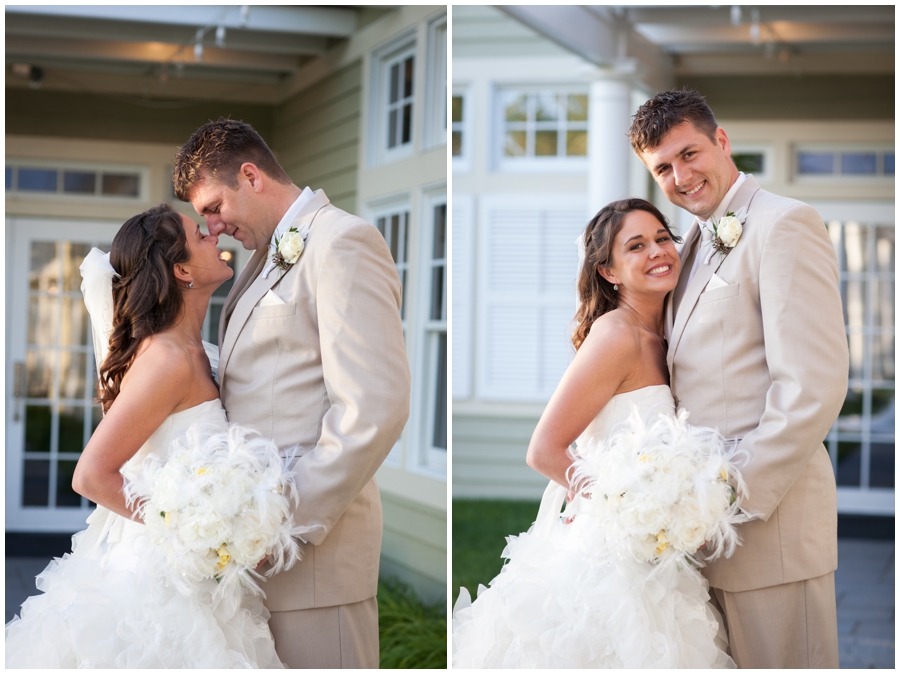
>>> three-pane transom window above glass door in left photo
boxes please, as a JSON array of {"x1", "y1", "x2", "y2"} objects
[{"x1": 6, "y1": 161, "x2": 147, "y2": 201}]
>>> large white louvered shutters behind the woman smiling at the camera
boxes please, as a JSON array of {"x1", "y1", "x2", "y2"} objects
[{"x1": 474, "y1": 195, "x2": 587, "y2": 402}]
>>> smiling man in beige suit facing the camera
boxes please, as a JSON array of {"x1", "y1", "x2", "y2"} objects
[{"x1": 628, "y1": 90, "x2": 849, "y2": 668}]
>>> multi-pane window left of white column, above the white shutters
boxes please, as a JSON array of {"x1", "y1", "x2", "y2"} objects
[{"x1": 498, "y1": 89, "x2": 588, "y2": 169}]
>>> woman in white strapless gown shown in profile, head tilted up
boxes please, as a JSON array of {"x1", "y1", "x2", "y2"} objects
[{"x1": 6, "y1": 204, "x2": 282, "y2": 668}]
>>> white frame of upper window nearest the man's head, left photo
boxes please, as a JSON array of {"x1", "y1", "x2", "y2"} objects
[{"x1": 369, "y1": 31, "x2": 421, "y2": 166}]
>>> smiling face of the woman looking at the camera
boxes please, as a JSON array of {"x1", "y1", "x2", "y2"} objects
[{"x1": 599, "y1": 210, "x2": 681, "y2": 295}]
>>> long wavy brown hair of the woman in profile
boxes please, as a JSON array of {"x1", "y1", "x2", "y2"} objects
[{"x1": 97, "y1": 204, "x2": 190, "y2": 412}]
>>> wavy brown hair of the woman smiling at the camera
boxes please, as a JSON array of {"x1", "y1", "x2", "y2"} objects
[{"x1": 572, "y1": 199, "x2": 681, "y2": 350}]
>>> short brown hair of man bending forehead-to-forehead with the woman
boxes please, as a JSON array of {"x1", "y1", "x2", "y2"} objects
[{"x1": 172, "y1": 118, "x2": 291, "y2": 201}]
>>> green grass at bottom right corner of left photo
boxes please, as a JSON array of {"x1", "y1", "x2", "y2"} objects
[{"x1": 378, "y1": 580, "x2": 448, "y2": 669}]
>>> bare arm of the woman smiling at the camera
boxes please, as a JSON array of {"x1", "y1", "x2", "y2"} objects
[{"x1": 525, "y1": 314, "x2": 640, "y2": 489}]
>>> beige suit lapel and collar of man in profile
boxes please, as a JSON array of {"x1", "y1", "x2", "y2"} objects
[{"x1": 219, "y1": 190, "x2": 330, "y2": 383}]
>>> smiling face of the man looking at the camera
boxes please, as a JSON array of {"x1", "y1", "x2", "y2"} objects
[{"x1": 640, "y1": 122, "x2": 738, "y2": 220}]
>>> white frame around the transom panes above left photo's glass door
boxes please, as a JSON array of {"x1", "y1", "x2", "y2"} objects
[{"x1": 6, "y1": 157, "x2": 150, "y2": 205}]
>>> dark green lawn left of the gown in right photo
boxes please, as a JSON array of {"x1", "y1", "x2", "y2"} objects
[{"x1": 451, "y1": 500, "x2": 540, "y2": 602}]
